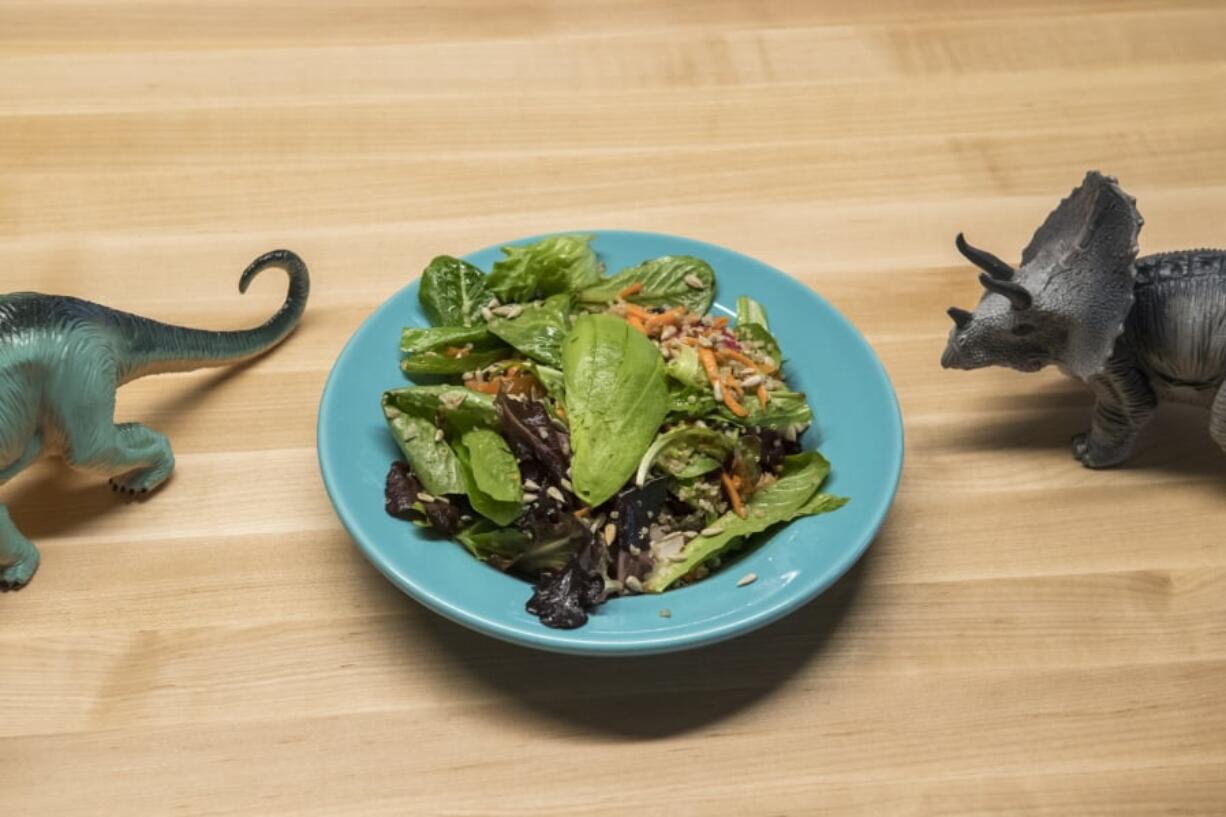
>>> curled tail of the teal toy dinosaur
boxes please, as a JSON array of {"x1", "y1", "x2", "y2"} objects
[{"x1": 116, "y1": 250, "x2": 310, "y2": 383}]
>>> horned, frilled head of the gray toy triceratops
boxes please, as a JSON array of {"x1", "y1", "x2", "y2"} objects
[{"x1": 940, "y1": 171, "x2": 1144, "y2": 379}]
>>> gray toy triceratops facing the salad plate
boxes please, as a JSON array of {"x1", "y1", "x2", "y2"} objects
[{"x1": 940, "y1": 172, "x2": 1226, "y2": 469}]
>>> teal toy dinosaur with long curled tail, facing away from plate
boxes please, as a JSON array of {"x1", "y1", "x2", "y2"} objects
[{"x1": 0, "y1": 250, "x2": 310, "y2": 590}]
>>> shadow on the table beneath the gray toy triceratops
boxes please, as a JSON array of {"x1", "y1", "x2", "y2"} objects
[{"x1": 942, "y1": 380, "x2": 1226, "y2": 485}]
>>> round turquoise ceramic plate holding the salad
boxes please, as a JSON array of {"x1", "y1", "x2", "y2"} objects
[{"x1": 318, "y1": 231, "x2": 902, "y2": 655}]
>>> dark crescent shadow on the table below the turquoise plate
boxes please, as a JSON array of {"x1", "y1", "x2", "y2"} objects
[{"x1": 372, "y1": 521, "x2": 889, "y2": 740}]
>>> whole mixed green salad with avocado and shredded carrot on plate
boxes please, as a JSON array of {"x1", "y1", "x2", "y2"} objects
[{"x1": 383, "y1": 236, "x2": 847, "y2": 627}]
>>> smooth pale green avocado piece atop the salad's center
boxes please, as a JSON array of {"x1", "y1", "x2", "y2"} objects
[{"x1": 562, "y1": 314, "x2": 668, "y2": 507}]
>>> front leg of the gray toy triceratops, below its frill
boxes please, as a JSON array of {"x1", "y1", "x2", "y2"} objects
[{"x1": 1073, "y1": 353, "x2": 1157, "y2": 469}]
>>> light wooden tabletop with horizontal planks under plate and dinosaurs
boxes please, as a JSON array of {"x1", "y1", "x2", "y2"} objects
[{"x1": 0, "y1": 0, "x2": 1226, "y2": 817}]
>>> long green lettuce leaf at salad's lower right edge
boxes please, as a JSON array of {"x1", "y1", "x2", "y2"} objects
[{"x1": 642, "y1": 451, "x2": 846, "y2": 593}]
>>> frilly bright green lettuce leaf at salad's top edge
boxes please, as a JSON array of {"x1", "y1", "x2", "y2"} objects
[{"x1": 487, "y1": 236, "x2": 601, "y2": 302}]
